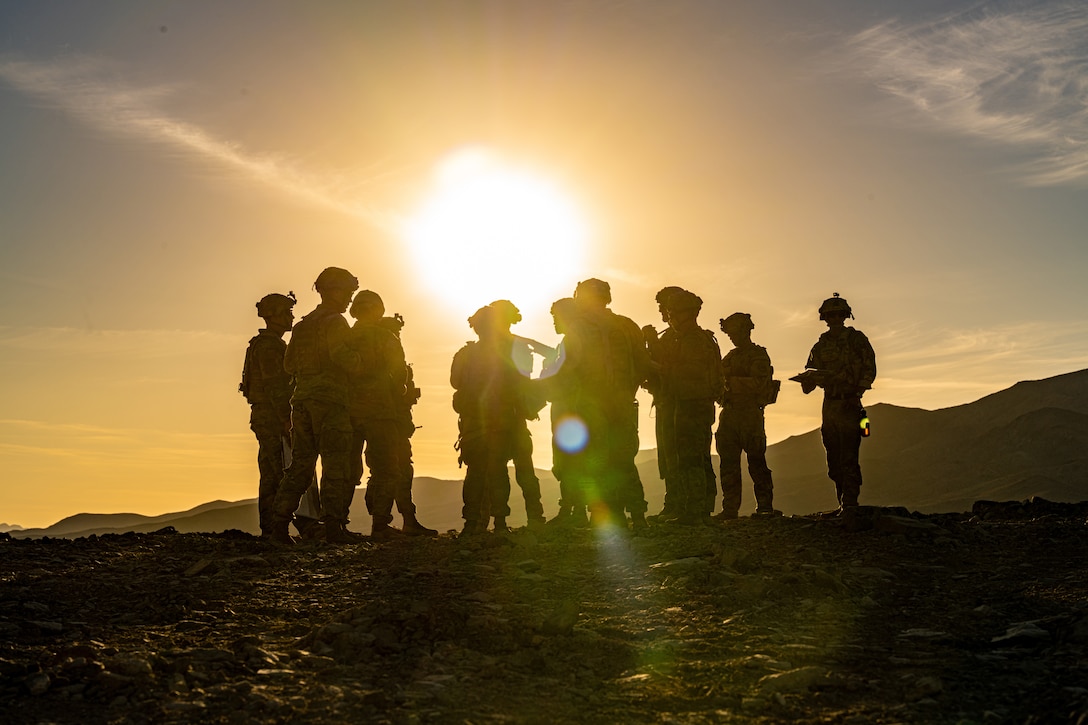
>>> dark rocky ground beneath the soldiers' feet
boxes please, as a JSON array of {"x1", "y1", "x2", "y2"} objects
[{"x1": 0, "y1": 501, "x2": 1088, "y2": 723}]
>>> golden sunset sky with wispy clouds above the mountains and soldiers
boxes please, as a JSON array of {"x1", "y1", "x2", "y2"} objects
[{"x1": 0, "y1": 0, "x2": 1088, "y2": 527}]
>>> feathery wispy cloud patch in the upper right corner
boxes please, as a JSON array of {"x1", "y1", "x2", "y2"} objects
[{"x1": 849, "y1": 1, "x2": 1088, "y2": 185}]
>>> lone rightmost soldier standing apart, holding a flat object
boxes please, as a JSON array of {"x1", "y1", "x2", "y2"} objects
[{"x1": 790, "y1": 292, "x2": 877, "y2": 511}]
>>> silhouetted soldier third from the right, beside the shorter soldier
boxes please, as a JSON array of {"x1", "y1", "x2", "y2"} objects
[{"x1": 647, "y1": 290, "x2": 721, "y2": 525}]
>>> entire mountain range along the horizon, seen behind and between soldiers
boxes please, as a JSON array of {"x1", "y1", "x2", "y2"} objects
[{"x1": 14, "y1": 370, "x2": 1088, "y2": 538}]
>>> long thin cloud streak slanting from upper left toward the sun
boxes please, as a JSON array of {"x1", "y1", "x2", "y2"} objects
[{"x1": 0, "y1": 58, "x2": 396, "y2": 229}]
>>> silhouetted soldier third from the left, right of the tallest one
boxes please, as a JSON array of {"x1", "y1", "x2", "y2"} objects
[{"x1": 348, "y1": 290, "x2": 437, "y2": 540}]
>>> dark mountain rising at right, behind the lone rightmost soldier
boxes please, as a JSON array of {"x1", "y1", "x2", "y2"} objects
[{"x1": 770, "y1": 363, "x2": 1088, "y2": 513}]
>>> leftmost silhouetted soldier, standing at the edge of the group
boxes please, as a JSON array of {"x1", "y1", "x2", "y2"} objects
[{"x1": 238, "y1": 292, "x2": 295, "y2": 536}]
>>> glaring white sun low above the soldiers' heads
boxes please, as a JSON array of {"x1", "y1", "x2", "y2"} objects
[{"x1": 403, "y1": 148, "x2": 588, "y2": 310}]
